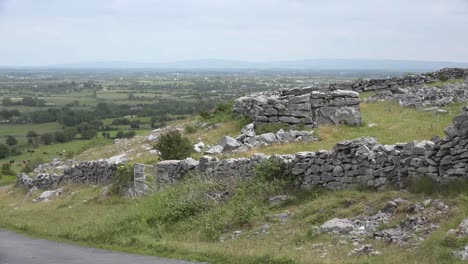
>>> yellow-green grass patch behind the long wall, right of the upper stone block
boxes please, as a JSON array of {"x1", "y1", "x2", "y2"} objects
[{"x1": 228, "y1": 102, "x2": 462, "y2": 156}]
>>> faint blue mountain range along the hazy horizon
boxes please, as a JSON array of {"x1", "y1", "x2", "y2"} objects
[{"x1": 42, "y1": 59, "x2": 468, "y2": 72}]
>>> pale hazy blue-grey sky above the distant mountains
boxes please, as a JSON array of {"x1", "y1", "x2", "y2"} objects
[{"x1": 0, "y1": 0, "x2": 468, "y2": 65}]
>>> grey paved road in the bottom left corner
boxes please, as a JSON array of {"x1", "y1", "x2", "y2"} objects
[{"x1": 0, "y1": 230, "x2": 197, "y2": 264}]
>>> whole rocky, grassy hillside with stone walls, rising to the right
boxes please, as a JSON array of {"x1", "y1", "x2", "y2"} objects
[{"x1": 0, "y1": 71, "x2": 468, "y2": 263}]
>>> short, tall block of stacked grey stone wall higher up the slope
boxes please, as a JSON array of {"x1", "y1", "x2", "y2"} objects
[{"x1": 233, "y1": 88, "x2": 361, "y2": 127}]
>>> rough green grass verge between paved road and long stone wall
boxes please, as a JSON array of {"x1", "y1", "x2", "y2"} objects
[{"x1": 0, "y1": 179, "x2": 468, "y2": 264}]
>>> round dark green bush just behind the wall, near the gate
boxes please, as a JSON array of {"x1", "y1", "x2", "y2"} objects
[{"x1": 154, "y1": 130, "x2": 193, "y2": 160}]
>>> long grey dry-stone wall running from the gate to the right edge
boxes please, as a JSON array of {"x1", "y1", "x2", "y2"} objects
[{"x1": 155, "y1": 107, "x2": 468, "y2": 189}]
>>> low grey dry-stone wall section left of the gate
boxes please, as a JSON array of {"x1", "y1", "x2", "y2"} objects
[{"x1": 17, "y1": 161, "x2": 116, "y2": 189}]
